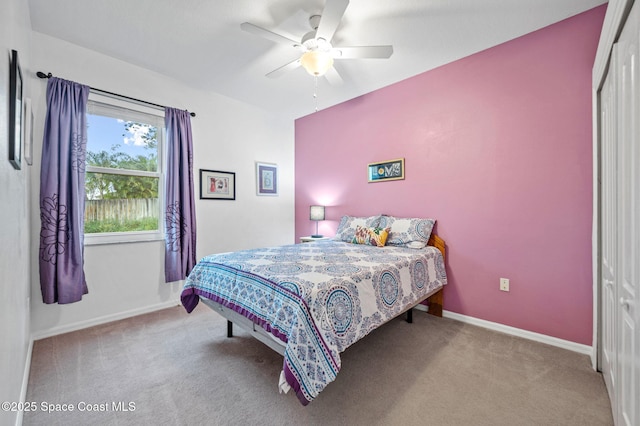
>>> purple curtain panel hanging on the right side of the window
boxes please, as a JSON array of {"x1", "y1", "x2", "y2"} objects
[{"x1": 164, "y1": 108, "x2": 196, "y2": 282}]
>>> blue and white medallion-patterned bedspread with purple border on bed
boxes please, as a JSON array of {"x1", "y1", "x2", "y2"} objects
[{"x1": 181, "y1": 240, "x2": 447, "y2": 405}]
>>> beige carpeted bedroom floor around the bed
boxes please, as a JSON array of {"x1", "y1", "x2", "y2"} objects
[{"x1": 23, "y1": 304, "x2": 613, "y2": 426}]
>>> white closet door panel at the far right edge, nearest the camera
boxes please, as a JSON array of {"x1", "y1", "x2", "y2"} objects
[{"x1": 617, "y1": 2, "x2": 640, "y2": 426}]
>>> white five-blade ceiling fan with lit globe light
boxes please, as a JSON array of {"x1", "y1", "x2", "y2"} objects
[{"x1": 240, "y1": 0, "x2": 393, "y2": 84}]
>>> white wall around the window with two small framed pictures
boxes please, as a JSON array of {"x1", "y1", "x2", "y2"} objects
[{"x1": 31, "y1": 33, "x2": 294, "y2": 338}]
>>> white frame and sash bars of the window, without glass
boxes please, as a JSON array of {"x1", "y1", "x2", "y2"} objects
[{"x1": 83, "y1": 91, "x2": 166, "y2": 246}]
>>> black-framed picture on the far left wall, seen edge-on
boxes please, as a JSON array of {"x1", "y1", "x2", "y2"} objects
[{"x1": 9, "y1": 50, "x2": 23, "y2": 170}]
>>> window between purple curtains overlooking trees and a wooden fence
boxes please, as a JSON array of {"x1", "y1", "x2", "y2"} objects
[{"x1": 84, "y1": 93, "x2": 164, "y2": 244}]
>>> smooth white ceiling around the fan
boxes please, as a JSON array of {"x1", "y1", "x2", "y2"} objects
[{"x1": 28, "y1": 0, "x2": 606, "y2": 118}]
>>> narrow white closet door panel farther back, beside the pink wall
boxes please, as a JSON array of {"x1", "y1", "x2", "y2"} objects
[{"x1": 599, "y1": 42, "x2": 618, "y2": 415}]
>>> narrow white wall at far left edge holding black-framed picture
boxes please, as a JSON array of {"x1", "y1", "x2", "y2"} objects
[{"x1": 0, "y1": 0, "x2": 31, "y2": 425}]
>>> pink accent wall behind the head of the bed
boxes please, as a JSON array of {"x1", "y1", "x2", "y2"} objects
[{"x1": 295, "y1": 6, "x2": 606, "y2": 345}]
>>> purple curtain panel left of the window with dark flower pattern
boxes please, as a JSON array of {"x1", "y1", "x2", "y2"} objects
[{"x1": 40, "y1": 77, "x2": 89, "y2": 304}]
